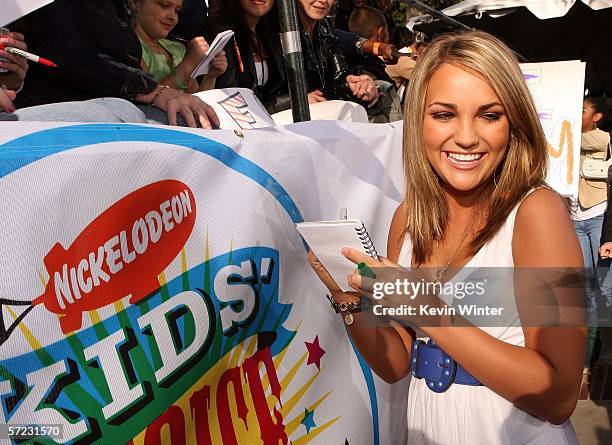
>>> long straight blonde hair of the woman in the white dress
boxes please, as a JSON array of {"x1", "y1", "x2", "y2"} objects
[{"x1": 402, "y1": 31, "x2": 547, "y2": 264}]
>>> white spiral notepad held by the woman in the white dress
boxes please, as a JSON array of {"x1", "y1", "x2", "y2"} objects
[{"x1": 296, "y1": 219, "x2": 378, "y2": 291}]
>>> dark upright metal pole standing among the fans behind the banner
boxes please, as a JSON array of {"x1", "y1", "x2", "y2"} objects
[{"x1": 278, "y1": 0, "x2": 310, "y2": 122}]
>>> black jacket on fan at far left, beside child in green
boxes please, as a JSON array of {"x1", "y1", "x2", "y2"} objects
[{"x1": 17, "y1": 0, "x2": 157, "y2": 107}]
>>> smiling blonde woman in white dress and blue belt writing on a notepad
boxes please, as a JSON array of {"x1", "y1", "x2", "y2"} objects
[{"x1": 309, "y1": 31, "x2": 586, "y2": 445}]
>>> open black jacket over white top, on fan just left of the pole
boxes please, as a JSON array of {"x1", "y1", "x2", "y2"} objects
[{"x1": 202, "y1": 17, "x2": 291, "y2": 114}]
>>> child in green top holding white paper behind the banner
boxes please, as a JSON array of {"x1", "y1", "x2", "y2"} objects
[{"x1": 128, "y1": 0, "x2": 227, "y2": 93}]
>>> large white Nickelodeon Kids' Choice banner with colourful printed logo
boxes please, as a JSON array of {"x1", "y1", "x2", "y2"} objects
[{"x1": 0, "y1": 121, "x2": 407, "y2": 445}]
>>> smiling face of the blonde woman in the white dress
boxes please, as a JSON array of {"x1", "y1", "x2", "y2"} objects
[{"x1": 423, "y1": 63, "x2": 510, "y2": 196}]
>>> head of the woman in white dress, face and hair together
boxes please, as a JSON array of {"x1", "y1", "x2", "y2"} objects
[{"x1": 403, "y1": 34, "x2": 547, "y2": 264}]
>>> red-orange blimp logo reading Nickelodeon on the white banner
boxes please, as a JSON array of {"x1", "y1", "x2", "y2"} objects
[{"x1": 32, "y1": 180, "x2": 196, "y2": 334}]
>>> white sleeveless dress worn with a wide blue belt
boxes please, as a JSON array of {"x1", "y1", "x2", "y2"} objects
[{"x1": 398, "y1": 196, "x2": 578, "y2": 445}]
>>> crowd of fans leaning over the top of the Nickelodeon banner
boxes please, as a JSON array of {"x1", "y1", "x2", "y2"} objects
[{"x1": 0, "y1": 0, "x2": 418, "y2": 128}]
